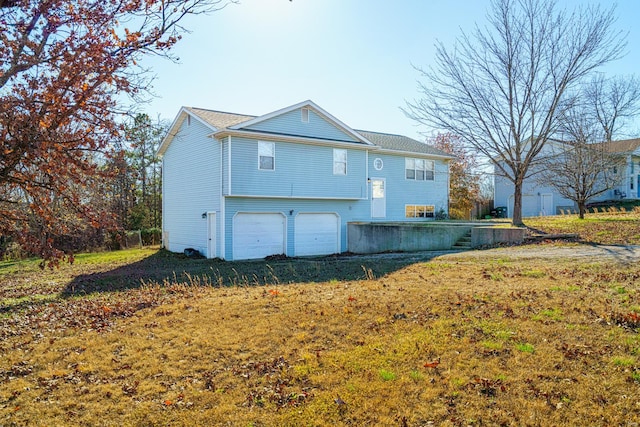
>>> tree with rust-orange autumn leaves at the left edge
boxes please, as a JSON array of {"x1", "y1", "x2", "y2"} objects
[{"x1": 0, "y1": 0, "x2": 230, "y2": 264}]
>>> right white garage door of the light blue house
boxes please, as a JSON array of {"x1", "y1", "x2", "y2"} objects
[{"x1": 295, "y1": 213, "x2": 340, "y2": 256}]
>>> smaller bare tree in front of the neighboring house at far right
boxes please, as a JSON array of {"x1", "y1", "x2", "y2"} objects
[{"x1": 537, "y1": 75, "x2": 640, "y2": 218}]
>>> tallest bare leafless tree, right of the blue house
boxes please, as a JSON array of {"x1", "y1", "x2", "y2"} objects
[{"x1": 405, "y1": 0, "x2": 626, "y2": 225}]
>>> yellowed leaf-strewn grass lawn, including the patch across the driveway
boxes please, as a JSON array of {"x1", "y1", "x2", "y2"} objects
[{"x1": 0, "y1": 214, "x2": 640, "y2": 426}]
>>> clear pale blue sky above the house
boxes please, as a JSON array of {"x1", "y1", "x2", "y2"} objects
[{"x1": 143, "y1": 0, "x2": 640, "y2": 140}]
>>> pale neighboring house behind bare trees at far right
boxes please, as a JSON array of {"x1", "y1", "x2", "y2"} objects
[{"x1": 494, "y1": 138, "x2": 640, "y2": 217}]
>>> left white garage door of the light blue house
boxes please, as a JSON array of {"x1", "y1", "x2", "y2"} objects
[{"x1": 233, "y1": 213, "x2": 285, "y2": 260}]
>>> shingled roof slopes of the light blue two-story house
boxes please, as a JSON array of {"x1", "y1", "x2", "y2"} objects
[{"x1": 176, "y1": 107, "x2": 453, "y2": 157}]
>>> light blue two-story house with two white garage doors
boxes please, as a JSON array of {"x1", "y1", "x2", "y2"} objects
[{"x1": 158, "y1": 101, "x2": 451, "y2": 260}]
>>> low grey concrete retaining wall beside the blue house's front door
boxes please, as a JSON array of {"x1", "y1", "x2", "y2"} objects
[{"x1": 347, "y1": 222, "x2": 524, "y2": 254}]
